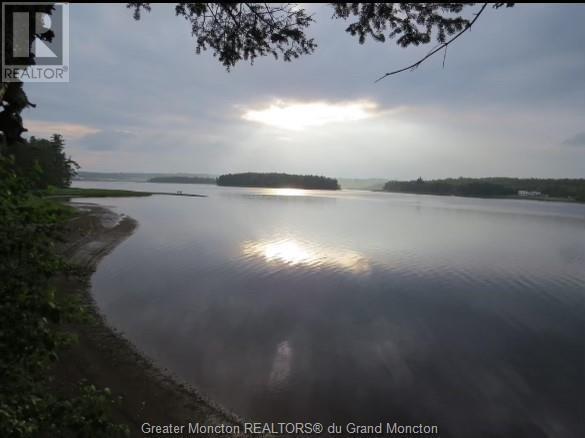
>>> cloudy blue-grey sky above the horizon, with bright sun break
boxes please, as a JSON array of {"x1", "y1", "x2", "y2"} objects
[{"x1": 23, "y1": 4, "x2": 585, "y2": 179}]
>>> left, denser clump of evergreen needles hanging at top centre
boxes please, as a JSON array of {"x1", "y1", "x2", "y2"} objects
[{"x1": 128, "y1": 3, "x2": 316, "y2": 70}]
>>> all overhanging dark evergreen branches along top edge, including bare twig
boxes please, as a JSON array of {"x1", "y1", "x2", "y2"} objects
[{"x1": 128, "y1": 3, "x2": 514, "y2": 77}]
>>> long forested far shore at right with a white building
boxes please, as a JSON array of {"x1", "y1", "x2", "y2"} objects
[{"x1": 383, "y1": 177, "x2": 585, "y2": 202}]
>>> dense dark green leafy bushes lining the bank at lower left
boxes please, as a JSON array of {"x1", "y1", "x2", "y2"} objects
[{"x1": 0, "y1": 157, "x2": 126, "y2": 437}]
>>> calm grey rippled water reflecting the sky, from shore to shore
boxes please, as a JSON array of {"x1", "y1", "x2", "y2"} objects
[{"x1": 76, "y1": 182, "x2": 585, "y2": 437}]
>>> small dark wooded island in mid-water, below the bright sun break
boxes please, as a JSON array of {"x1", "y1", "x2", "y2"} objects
[{"x1": 217, "y1": 172, "x2": 340, "y2": 190}]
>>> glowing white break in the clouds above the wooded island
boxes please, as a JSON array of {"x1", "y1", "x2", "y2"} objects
[{"x1": 242, "y1": 101, "x2": 377, "y2": 131}]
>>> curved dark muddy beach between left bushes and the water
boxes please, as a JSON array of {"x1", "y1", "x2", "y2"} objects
[{"x1": 53, "y1": 202, "x2": 242, "y2": 437}]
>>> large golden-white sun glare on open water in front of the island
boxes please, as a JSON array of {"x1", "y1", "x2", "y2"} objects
[{"x1": 242, "y1": 238, "x2": 370, "y2": 273}]
